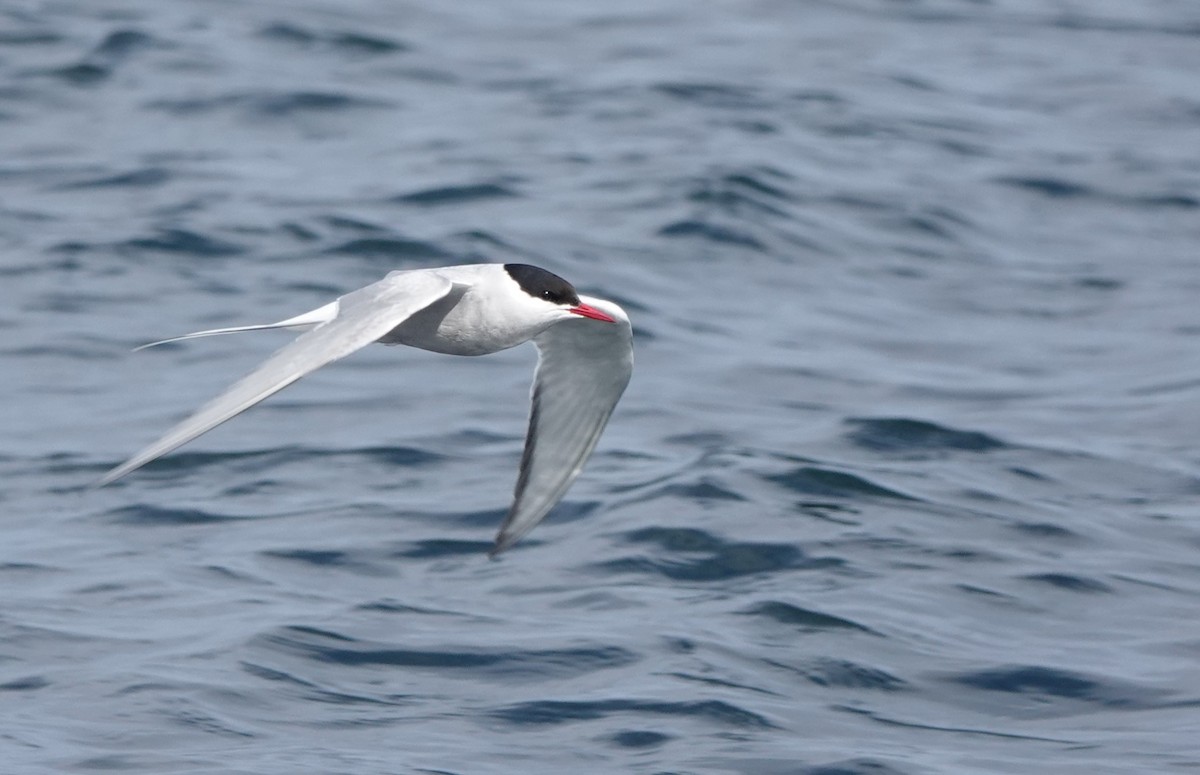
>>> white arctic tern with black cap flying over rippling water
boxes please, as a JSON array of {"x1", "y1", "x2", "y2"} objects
[{"x1": 98, "y1": 264, "x2": 634, "y2": 555}]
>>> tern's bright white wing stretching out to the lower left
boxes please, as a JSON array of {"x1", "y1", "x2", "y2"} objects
[{"x1": 97, "y1": 271, "x2": 454, "y2": 486}]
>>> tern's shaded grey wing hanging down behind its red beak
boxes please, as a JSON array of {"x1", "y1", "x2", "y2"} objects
[{"x1": 491, "y1": 298, "x2": 634, "y2": 555}]
